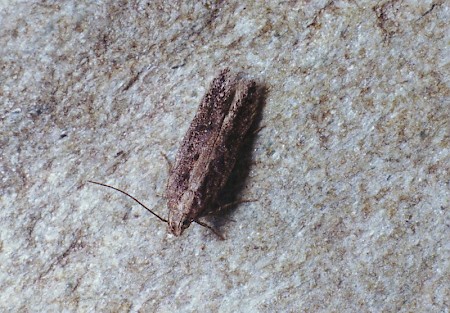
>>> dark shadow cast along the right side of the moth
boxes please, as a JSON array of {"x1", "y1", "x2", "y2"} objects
[{"x1": 205, "y1": 84, "x2": 268, "y2": 232}]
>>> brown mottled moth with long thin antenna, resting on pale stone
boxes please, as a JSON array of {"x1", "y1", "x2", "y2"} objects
[{"x1": 89, "y1": 68, "x2": 260, "y2": 239}]
